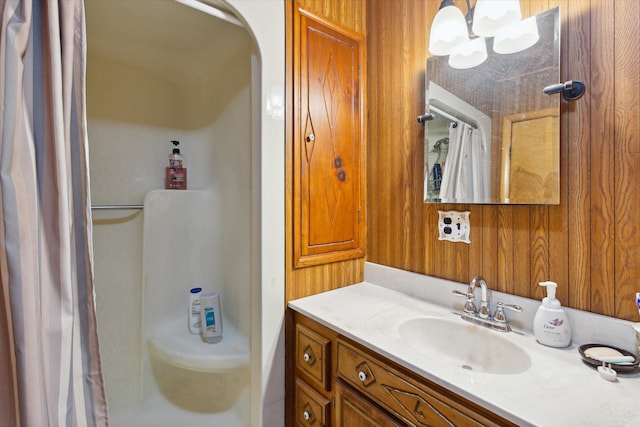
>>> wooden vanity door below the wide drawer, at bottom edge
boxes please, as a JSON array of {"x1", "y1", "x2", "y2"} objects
[{"x1": 336, "y1": 381, "x2": 405, "y2": 427}]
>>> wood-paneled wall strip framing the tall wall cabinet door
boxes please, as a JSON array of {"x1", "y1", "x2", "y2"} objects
[{"x1": 285, "y1": 0, "x2": 366, "y2": 301}]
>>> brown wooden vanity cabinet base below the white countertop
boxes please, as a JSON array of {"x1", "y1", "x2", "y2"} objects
[{"x1": 287, "y1": 311, "x2": 515, "y2": 427}]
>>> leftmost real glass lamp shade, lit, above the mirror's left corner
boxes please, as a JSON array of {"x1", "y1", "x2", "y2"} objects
[{"x1": 429, "y1": 6, "x2": 469, "y2": 55}]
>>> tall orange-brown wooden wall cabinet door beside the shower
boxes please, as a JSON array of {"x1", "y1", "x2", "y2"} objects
[{"x1": 293, "y1": 5, "x2": 366, "y2": 267}]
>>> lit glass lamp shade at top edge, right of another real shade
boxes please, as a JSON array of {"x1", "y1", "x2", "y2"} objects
[{"x1": 471, "y1": 0, "x2": 522, "y2": 37}]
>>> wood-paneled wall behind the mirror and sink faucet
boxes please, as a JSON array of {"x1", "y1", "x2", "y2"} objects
[{"x1": 367, "y1": 0, "x2": 640, "y2": 321}]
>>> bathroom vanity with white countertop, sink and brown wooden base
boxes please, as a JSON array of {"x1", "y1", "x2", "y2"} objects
[{"x1": 288, "y1": 266, "x2": 640, "y2": 426}]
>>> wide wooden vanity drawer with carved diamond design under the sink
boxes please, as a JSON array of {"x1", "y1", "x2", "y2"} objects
[{"x1": 337, "y1": 340, "x2": 501, "y2": 427}]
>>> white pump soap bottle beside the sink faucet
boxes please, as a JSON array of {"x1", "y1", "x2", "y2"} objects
[{"x1": 533, "y1": 282, "x2": 571, "y2": 347}]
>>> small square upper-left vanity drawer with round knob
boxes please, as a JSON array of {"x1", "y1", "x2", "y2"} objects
[{"x1": 295, "y1": 323, "x2": 331, "y2": 391}]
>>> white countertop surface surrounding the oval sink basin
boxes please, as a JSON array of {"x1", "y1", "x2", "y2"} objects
[{"x1": 289, "y1": 282, "x2": 640, "y2": 427}]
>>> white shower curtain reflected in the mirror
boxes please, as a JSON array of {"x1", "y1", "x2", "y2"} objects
[{"x1": 440, "y1": 122, "x2": 489, "y2": 203}]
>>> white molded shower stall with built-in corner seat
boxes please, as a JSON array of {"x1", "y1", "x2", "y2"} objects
[{"x1": 85, "y1": 0, "x2": 284, "y2": 427}]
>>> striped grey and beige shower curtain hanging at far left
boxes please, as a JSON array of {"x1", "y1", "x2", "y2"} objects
[{"x1": 0, "y1": 0, "x2": 108, "y2": 427}]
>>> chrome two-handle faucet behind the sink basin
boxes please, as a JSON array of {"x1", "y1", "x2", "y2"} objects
[{"x1": 453, "y1": 276, "x2": 522, "y2": 332}]
